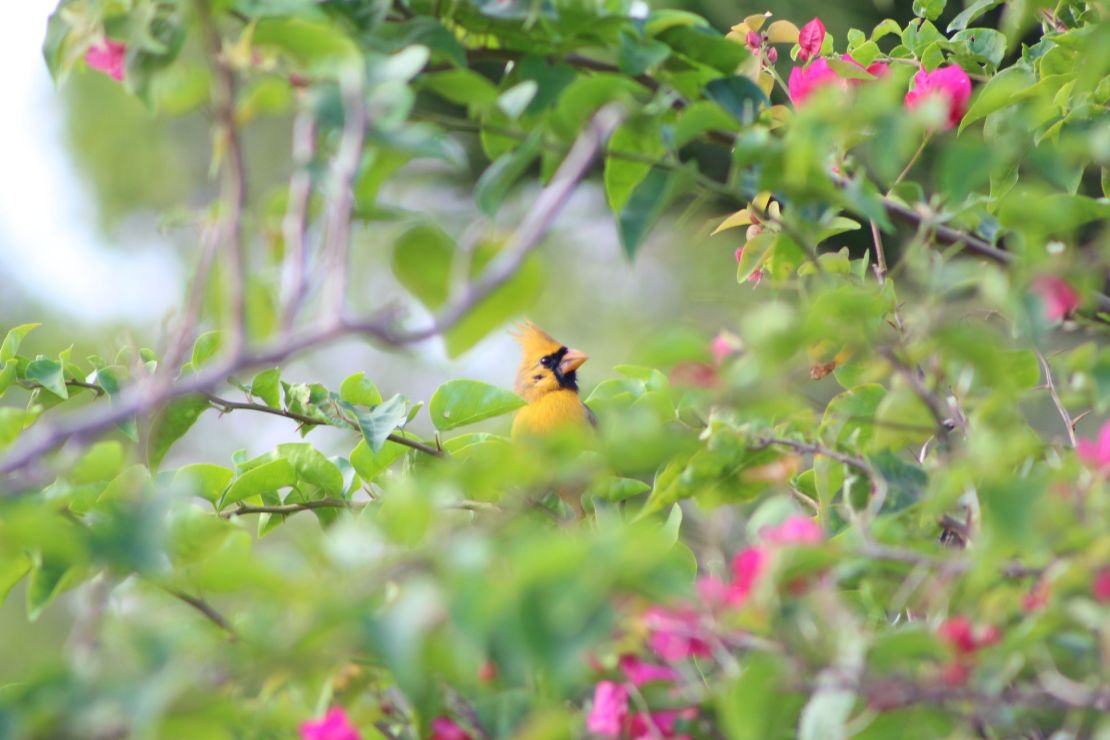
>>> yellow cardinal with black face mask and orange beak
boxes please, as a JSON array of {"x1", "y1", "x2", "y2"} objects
[{"x1": 513, "y1": 322, "x2": 597, "y2": 438}]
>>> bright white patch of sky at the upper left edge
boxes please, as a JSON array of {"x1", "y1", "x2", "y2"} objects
[{"x1": 0, "y1": 0, "x2": 180, "y2": 323}]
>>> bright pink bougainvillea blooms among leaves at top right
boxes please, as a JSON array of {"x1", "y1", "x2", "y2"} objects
[{"x1": 787, "y1": 18, "x2": 971, "y2": 129}]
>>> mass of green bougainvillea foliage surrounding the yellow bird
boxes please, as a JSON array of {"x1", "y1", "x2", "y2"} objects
[{"x1": 0, "y1": 0, "x2": 1110, "y2": 738}]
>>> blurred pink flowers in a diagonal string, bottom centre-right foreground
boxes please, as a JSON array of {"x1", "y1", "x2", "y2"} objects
[{"x1": 586, "y1": 516, "x2": 824, "y2": 740}]
